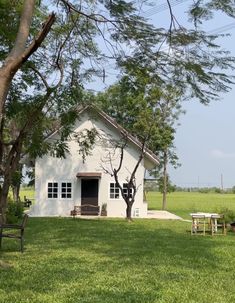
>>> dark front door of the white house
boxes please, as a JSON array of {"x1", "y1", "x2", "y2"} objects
[{"x1": 81, "y1": 179, "x2": 99, "y2": 215}]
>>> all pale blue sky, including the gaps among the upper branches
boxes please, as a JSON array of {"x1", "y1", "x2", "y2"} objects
[{"x1": 87, "y1": 0, "x2": 235, "y2": 188}]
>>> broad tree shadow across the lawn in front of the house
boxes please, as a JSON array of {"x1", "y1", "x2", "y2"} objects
[{"x1": 13, "y1": 218, "x2": 234, "y2": 268}]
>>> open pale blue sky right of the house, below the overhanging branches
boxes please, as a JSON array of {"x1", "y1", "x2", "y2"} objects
[{"x1": 169, "y1": 89, "x2": 235, "y2": 188}]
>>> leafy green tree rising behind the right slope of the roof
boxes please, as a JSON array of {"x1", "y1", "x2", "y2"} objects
[{"x1": 97, "y1": 77, "x2": 183, "y2": 209}]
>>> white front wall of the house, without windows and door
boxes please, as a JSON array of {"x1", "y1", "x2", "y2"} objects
[{"x1": 31, "y1": 113, "x2": 147, "y2": 217}]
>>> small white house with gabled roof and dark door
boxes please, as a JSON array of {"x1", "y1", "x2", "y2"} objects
[{"x1": 30, "y1": 107, "x2": 158, "y2": 218}]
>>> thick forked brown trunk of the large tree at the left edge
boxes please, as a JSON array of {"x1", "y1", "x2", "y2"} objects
[{"x1": 0, "y1": 0, "x2": 55, "y2": 221}]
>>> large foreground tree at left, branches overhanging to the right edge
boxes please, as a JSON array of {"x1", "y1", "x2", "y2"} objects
[{"x1": 0, "y1": 0, "x2": 235, "y2": 224}]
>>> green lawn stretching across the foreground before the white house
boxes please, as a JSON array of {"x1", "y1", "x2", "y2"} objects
[{"x1": 0, "y1": 194, "x2": 235, "y2": 303}]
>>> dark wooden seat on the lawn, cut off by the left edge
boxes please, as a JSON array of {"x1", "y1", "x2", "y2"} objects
[{"x1": 0, "y1": 214, "x2": 28, "y2": 252}]
